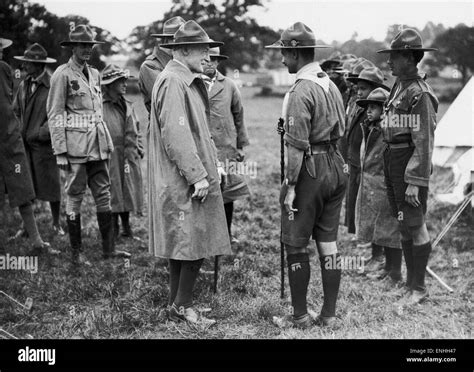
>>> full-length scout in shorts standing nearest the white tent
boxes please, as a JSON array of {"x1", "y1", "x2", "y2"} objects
[{"x1": 378, "y1": 28, "x2": 438, "y2": 305}]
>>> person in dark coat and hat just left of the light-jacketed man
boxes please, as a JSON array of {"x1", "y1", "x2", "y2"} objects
[{"x1": 13, "y1": 44, "x2": 64, "y2": 235}]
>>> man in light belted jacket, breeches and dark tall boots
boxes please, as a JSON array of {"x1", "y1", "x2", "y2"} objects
[{"x1": 47, "y1": 25, "x2": 129, "y2": 265}]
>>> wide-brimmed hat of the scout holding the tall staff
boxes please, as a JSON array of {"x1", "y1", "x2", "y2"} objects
[{"x1": 265, "y1": 22, "x2": 331, "y2": 49}]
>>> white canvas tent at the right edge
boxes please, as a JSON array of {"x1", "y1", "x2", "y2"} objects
[{"x1": 433, "y1": 78, "x2": 474, "y2": 204}]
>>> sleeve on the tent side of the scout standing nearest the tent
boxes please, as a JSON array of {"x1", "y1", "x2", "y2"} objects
[{"x1": 405, "y1": 93, "x2": 436, "y2": 187}]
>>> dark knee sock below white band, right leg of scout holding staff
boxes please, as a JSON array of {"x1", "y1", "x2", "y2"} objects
[{"x1": 318, "y1": 253, "x2": 341, "y2": 325}]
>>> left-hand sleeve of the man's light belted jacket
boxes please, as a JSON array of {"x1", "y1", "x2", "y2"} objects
[{"x1": 46, "y1": 70, "x2": 68, "y2": 155}]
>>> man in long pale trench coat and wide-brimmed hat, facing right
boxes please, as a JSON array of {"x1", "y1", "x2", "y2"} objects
[{"x1": 148, "y1": 21, "x2": 231, "y2": 325}]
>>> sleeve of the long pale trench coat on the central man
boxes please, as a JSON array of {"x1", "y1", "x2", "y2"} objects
[{"x1": 154, "y1": 79, "x2": 207, "y2": 186}]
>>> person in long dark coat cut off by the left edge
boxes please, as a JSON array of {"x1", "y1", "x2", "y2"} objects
[{"x1": 0, "y1": 38, "x2": 54, "y2": 254}]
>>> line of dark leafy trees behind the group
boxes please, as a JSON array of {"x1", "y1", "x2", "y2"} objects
[{"x1": 0, "y1": 0, "x2": 474, "y2": 82}]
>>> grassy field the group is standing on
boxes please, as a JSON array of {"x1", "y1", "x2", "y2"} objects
[{"x1": 0, "y1": 88, "x2": 474, "y2": 339}]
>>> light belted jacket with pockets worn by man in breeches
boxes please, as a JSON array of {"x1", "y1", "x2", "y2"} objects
[{"x1": 47, "y1": 57, "x2": 113, "y2": 163}]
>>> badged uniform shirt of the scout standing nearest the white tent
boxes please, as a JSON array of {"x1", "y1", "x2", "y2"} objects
[{"x1": 381, "y1": 74, "x2": 438, "y2": 187}]
